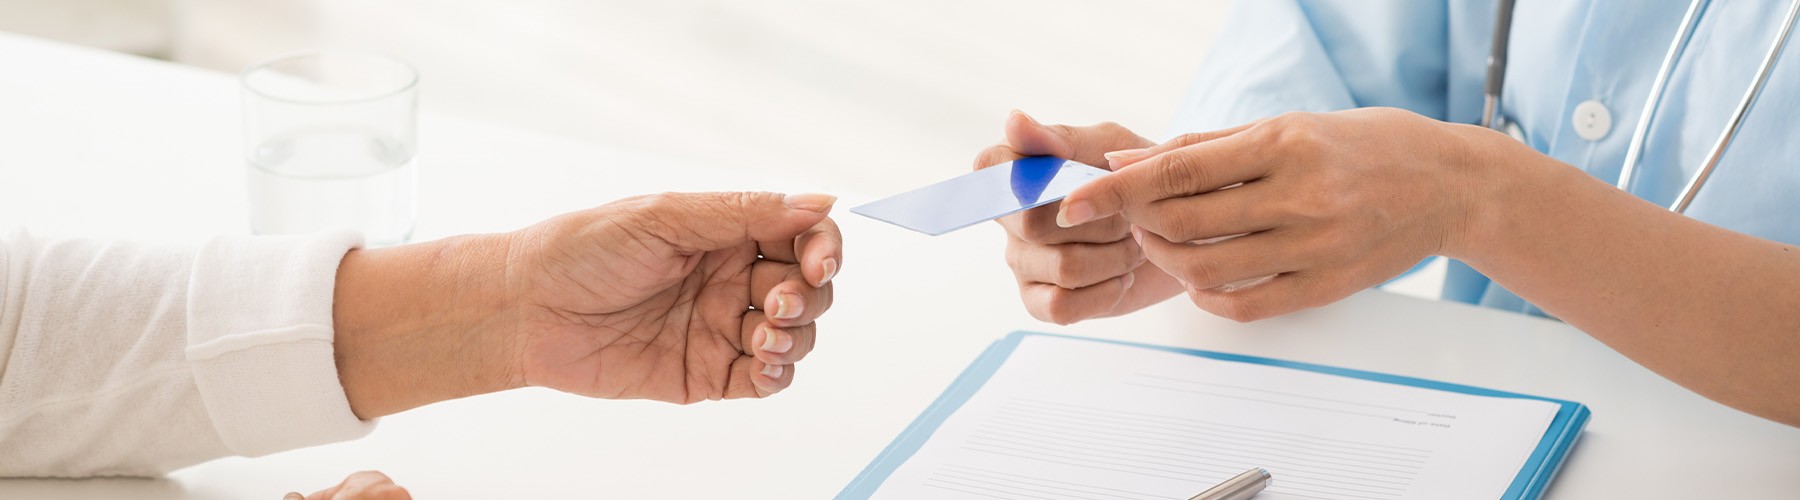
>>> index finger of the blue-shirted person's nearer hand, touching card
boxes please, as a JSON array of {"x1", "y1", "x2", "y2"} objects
[{"x1": 1057, "y1": 126, "x2": 1278, "y2": 227}]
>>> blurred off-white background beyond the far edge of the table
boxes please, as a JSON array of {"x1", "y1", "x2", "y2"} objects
[{"x1": 0, "y1": 0, "x2": 1226, "y2": 194}]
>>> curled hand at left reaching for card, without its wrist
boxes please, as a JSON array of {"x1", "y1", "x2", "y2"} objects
[{"x1": 508, "y1": 192, "x2": 842, "y2": 403}]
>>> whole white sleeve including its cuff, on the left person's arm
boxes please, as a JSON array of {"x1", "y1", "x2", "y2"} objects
[{"x1": 0, "y1": 230, "x2": 374, "y2": 477}]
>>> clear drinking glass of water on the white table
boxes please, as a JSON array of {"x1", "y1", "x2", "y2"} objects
[{"x1": 241, "y1": 50, "x2": 419, "y2": 246}]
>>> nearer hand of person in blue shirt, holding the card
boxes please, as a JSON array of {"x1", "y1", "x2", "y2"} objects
[{"x1": 1060, "y1": 108, "x2": 1472, "y2": 320}]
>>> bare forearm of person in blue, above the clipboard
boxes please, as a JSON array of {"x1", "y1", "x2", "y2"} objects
[{"x1": 1447, "y1": 129, "x2": 1800, "y2": 424}]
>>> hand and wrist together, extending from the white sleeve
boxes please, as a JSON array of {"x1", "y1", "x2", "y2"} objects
[{"x1": 335, "y1": 192, "x2": 842, "y2": 419}]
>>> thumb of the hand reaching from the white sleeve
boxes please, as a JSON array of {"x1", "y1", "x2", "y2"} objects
[{"x1": 632, "y1": 192, "x2": 837, "y2": 254}]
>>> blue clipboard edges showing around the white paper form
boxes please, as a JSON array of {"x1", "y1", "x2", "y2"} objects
[{"x1": 835, "y1": 331, "x2": 1591, "y2": 500}]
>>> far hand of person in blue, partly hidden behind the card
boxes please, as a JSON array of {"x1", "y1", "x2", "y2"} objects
[{"x1": 976, "y1": 112, "x2": 1181, "y2": 324}]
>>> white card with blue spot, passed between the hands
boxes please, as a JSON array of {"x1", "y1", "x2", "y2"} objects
[{"x1": 850, "y1": 156, "x2": 1109, "y2": 236}]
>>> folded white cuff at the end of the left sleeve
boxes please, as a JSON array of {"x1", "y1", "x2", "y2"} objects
[{"x1": 185, "y1": 232, "x2": 374, "y2": 457}]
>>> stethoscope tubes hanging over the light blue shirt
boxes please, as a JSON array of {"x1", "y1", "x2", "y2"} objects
[{"x1": 1481, "y1": 0, "x2": 1800, "y2": 214}]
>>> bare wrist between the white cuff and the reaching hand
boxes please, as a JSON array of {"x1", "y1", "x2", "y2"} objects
[{"x1": 333, "y1": 234, "x2": 522, "y2": 419}]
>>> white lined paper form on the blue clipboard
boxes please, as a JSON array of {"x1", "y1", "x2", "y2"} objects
[{"x1": 873, "y1": 336, "x2": 1559, "y2": 500}]
